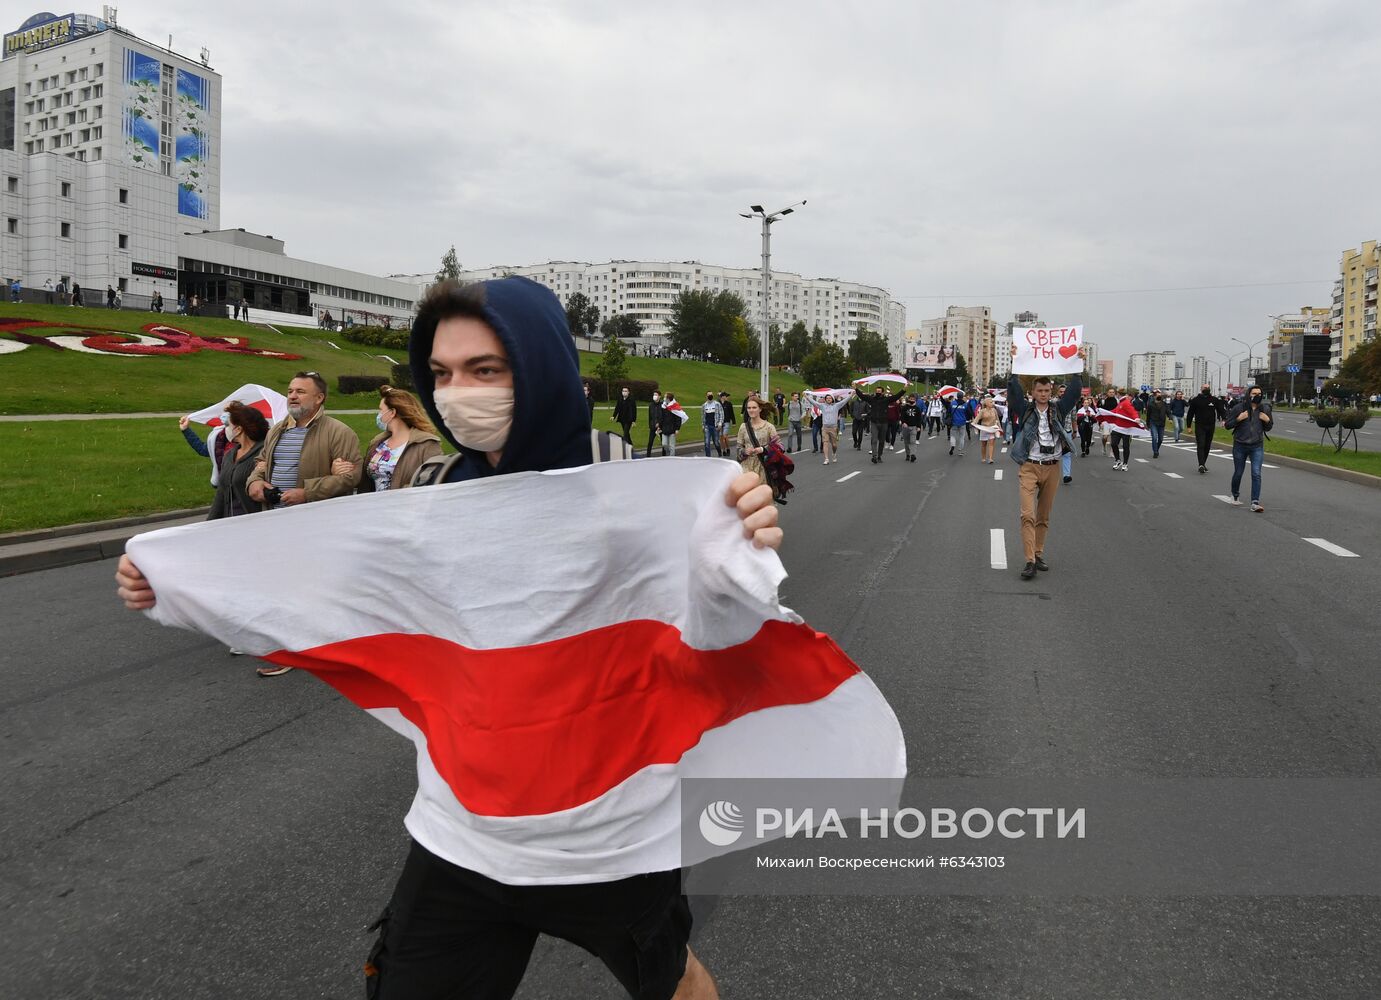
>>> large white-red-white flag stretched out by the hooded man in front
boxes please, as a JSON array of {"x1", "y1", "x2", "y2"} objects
[{"x1": 127, "y1": 459, "x2": 906, "y2": 884}]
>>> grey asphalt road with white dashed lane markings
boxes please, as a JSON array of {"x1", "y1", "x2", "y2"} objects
[{"x1": 0, "y1": 425, "x2": 1381, "y2": 1000}]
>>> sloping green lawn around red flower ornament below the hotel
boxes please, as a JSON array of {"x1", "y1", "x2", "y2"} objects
[{"x1": 0, "y1": 304, "x2": 406, "y2": 414}]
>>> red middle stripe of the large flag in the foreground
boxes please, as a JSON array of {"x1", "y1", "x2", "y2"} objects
[{"x1": 264, "y1": 620, "x2": 859, "y2": 816}]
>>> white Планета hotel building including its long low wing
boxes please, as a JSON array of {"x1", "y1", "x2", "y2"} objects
[{"x1": 0, "y1": 7, "x2": 418, "y2": 326}]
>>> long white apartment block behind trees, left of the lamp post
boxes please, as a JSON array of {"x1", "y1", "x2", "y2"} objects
[{"x1": 452, "y1": 261, "x2": 906, "y2": 363}]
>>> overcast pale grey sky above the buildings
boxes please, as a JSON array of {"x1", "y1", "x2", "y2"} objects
[{"x1": 148, "y1": 0, "x2": 1381, "y2": 370}]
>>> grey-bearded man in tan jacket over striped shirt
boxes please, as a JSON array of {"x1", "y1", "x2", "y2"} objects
[{"x1": 247, "y1": 372, "x2": 362, "y2": 677}]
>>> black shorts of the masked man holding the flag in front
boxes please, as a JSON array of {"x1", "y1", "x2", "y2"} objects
[{"x1": 365, "y1": 841, "x2": 691, "y2": 1000}]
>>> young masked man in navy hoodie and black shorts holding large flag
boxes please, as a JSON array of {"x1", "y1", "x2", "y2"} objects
[{"x1": 116, "y1": 278, "x2": 782, "y2": 1000}]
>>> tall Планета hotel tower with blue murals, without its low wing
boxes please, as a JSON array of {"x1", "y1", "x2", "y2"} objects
[{"x1": 0, "y1": 7, "x2": 221, "y2": 298}]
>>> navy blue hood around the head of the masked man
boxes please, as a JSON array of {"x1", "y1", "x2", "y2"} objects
[{"x1": 407, "y1": 278, "x2": 590, "y2": 482}]
